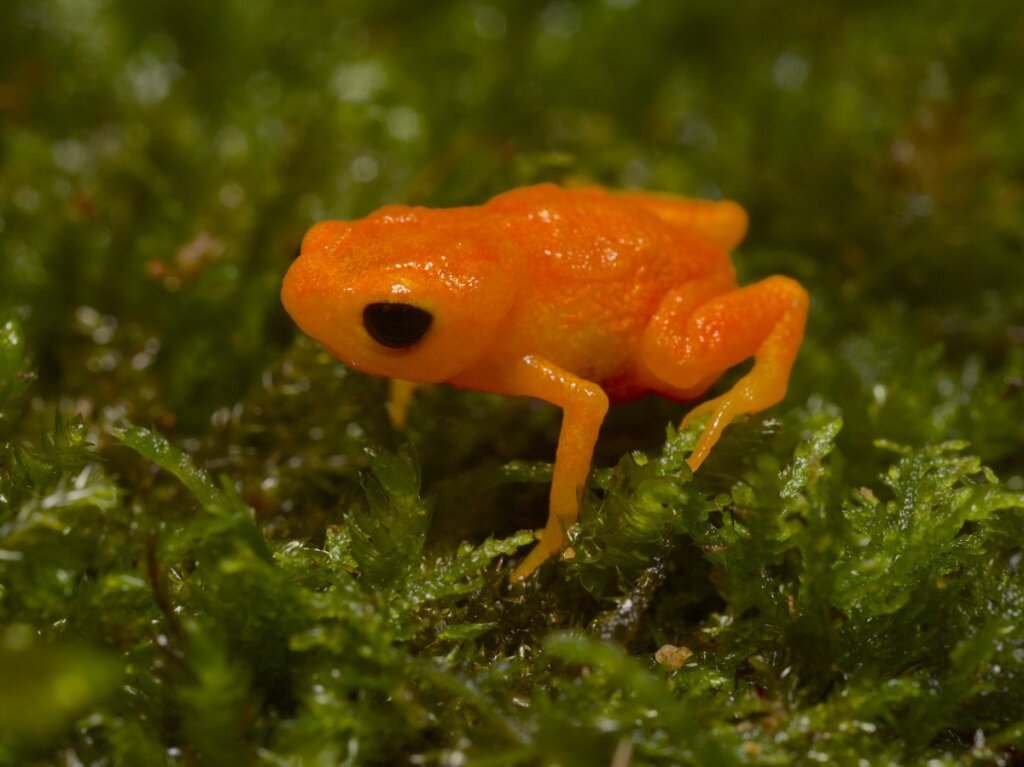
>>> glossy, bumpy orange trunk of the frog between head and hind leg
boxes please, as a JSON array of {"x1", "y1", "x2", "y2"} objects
[{"x1": 478, "y1": 184, "x2": 733, "y2": 391}]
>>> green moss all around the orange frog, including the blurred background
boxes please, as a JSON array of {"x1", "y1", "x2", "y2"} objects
[{"x1": 0, "y1": 0, "x2": 1024, "y2": 767}]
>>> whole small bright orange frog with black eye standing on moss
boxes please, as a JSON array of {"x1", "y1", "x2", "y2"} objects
[{"x1": 282, "y1": 184, "x2": 808, "y2": 580}]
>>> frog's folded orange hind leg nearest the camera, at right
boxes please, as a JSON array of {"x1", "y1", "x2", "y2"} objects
[{"x1": 641, "y1": 276, "x2": 808, "y2": 470}]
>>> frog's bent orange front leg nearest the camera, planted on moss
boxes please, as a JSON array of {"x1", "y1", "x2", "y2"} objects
[{"x1": 503, "y1": 356, "x2": 608, "y2": 581}]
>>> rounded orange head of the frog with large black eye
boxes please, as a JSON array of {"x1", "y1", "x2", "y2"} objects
[{"x1": 281, "y1": 206, "x2": 517, "y2": 383}]
